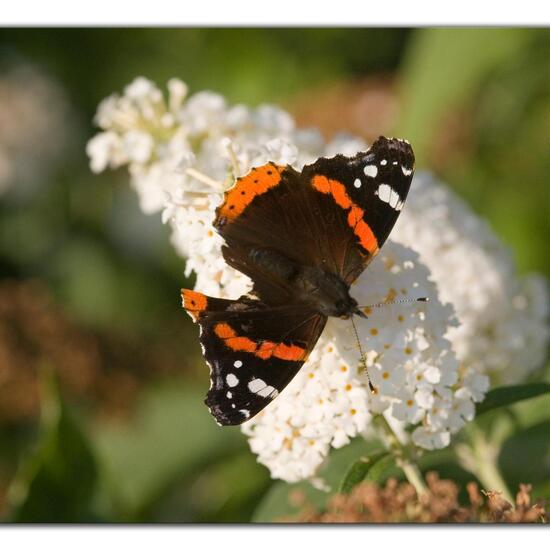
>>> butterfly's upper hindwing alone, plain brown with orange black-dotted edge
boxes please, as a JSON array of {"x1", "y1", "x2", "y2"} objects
[{"x1": 214, "y1": 163, "x2": 340, "y2": 305}]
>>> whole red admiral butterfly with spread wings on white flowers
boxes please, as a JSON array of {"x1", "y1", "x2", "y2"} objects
[{"x1": 182, "y1": 137, "x2": 414, "y2": 425}]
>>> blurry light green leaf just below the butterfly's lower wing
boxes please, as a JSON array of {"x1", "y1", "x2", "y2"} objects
[{"x1": 94, "y1": 380, "x2": 246, "y2": 521}]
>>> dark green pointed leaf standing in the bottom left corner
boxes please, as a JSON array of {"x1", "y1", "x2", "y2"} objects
[{"x1": 9, "y1": 377, "x2": 98, "y2": 523}]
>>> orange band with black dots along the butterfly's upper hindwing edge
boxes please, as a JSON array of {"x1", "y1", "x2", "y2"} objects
[{"x1": 218, "y1": 163, "x2": 285, "y2": 220}]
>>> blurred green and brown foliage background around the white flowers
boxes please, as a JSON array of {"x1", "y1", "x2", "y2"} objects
[{"x1": 0, "y1": 28, "x2": 550, "y2": 522}]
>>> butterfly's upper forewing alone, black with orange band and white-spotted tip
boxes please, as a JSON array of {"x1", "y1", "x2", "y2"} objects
[{"x1": 302, "y1": 137, "x2": 415, "y2": 284}]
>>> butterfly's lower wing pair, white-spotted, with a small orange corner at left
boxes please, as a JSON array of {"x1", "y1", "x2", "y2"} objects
[{"x1": 182, "y1": 290, "x2": 326, "y2": 426}]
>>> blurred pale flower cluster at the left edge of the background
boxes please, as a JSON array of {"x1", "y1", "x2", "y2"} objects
[{"x1": 0, "y1": 64, "x2": 73, "y2": 194}]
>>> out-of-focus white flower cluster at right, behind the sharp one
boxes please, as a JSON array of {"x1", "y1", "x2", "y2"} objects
[{"x1": 398, "y1": 173, "x2": 550, "y2": 384}]
